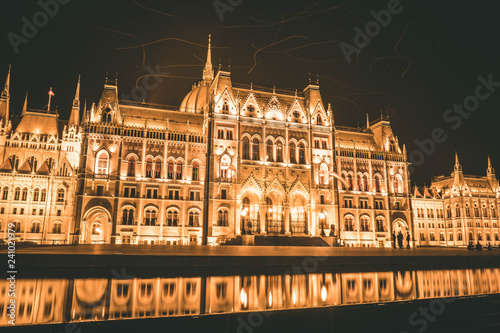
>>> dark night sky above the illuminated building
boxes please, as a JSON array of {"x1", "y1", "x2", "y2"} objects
[{"x1": 0, "y1": 0, "x2": 500, "y2": 185}]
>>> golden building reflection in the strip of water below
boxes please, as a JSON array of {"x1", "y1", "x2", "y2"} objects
[{"x1": 0, "y1": 268, "x2": 500, "y2": 326}]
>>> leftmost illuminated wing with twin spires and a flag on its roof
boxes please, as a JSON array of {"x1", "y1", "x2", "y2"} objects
[{"x1": 0, "y1": 69, "x2": 82, "y2": 244}]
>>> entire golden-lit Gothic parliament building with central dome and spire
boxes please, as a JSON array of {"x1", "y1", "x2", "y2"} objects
[{"x1": 0, "y1": 38, "x2": 500, "y2": 247}]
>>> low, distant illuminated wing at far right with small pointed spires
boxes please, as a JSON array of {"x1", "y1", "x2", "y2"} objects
[{"x1": 413, "y1": 156, "x2": 500, "y2": 246}]
